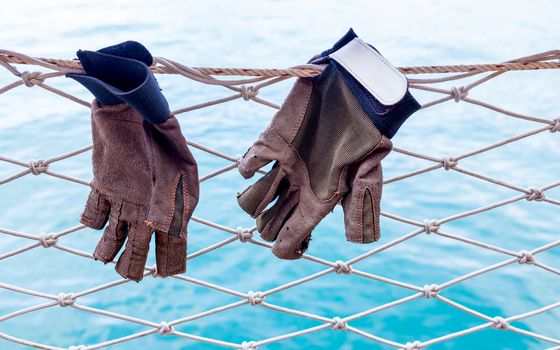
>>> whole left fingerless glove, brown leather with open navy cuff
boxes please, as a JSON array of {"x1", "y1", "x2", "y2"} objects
[{"x1": 68, "y1": 42, "x2": 199, "y2": 281}]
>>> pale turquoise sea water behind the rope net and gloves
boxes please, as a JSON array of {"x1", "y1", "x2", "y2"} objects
[{"x1": 0, "y1": 1, "x2": 560, "y2": 350}]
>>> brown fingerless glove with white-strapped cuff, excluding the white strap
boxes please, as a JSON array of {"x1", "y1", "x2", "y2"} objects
[{"x1": 237, "y1": 31, "x2": 420, "y2": 259}]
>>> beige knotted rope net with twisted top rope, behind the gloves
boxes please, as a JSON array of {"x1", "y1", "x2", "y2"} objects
[{"x1": 0, "y1": 50, "x2": 560, "y2": 350}]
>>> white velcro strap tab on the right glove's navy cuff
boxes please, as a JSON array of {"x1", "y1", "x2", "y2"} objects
[{"x1": 329, "y1": 38, "x2": 407, "y2": 106}]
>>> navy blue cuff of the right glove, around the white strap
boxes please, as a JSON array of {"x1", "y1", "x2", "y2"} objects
[{"x1": 313, "y1": 28, "x2": 421, "y2": 138}]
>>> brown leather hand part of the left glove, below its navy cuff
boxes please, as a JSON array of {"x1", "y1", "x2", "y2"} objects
[{"x1": 80, "y1": 101, "x2": 198, "y2": 281}]
